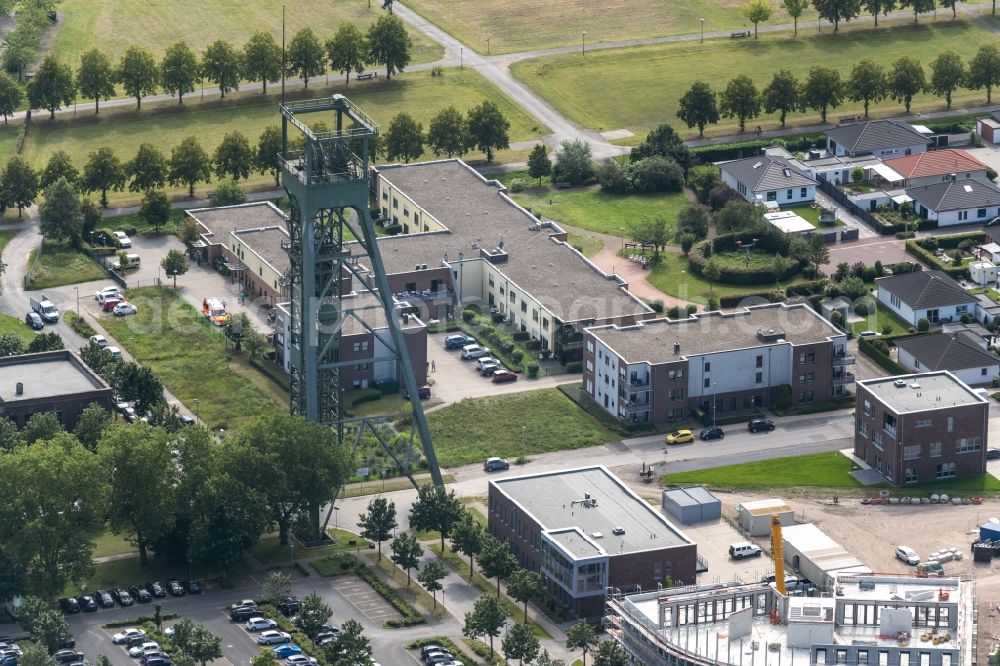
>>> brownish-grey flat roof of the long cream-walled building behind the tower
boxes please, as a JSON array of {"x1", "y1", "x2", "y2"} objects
[{"x1": 375, "y1": 160, "x2": 651, "y2": 322}]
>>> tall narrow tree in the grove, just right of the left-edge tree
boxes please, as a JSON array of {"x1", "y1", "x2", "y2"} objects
[{"x1": 97, "y1": 422, "x2": 175, "y2": 566}]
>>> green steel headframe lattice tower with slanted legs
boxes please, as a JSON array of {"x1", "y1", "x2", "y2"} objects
[{"x1": 278, "y1": 95, "x2": 442, "y2": 485}]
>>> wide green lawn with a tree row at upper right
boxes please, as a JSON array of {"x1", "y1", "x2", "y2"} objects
[{"x1": 512, "y1": 20, "x2": 996, "y2": 134}]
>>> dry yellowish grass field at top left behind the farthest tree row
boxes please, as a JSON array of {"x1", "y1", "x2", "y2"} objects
[{"x1": 52, "y1": 0, "x2": 444, "y2": 67}]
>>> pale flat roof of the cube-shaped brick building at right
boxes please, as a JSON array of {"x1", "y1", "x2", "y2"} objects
[{"x1": 858, "y1": 372, "x2": 987, "y2": 414}]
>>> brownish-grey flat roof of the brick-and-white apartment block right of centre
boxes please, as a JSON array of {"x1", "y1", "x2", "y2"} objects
[{"x1": 587, "y1": 303, "x2": 844, "y2": 365}]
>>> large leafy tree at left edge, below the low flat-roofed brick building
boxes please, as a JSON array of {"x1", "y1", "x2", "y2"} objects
[{"x1": 0, "y1": 433, "x2": 107, "y2": 597}]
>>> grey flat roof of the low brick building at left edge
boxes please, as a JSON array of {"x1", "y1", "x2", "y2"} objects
[{"x1": 0, "y1": 351, "x2": 109, "y2": 403}]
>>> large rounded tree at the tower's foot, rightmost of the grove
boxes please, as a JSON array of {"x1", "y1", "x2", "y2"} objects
[{"x1": 226, "y1": 414, "x2": 350, "y2": 545}]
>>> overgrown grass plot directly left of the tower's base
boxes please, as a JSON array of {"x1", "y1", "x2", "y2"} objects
[{"x1": 101, "y1": 287, "x2": 288, "y2": 430}]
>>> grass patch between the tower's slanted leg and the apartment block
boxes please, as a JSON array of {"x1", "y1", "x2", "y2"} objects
[{"x1": 427, "y1": 388, "x2": 621, "y2": 467}]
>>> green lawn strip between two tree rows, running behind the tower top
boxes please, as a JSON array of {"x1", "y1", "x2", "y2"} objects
[{"x1": 23, "y1": 69, "x2": 548, "y2": 205}]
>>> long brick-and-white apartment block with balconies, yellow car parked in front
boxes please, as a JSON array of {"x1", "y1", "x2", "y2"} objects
[{"x1": 583, "y1": 303, "x2": 854, "y2": 423}]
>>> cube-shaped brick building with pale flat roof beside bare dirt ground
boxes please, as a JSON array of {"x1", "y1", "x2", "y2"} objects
[{"x1": 854, "y1": 372, "x2": 989, "y2": 485}]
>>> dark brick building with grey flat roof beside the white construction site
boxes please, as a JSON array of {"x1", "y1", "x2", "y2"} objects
[{"x1": 489, "y1": 466, "x2": 697, "y2": 617}]
